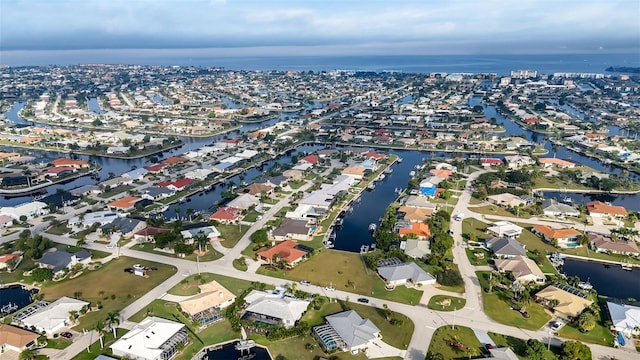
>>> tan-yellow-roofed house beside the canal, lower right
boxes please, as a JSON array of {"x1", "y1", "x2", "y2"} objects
[{"x1": 534, "y1": 284, "x2": 593, "y2": 320}]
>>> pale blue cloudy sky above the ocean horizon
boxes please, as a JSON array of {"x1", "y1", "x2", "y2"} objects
[{"x1": 0, "y1": 0, "x2": 640, "y2": 55}]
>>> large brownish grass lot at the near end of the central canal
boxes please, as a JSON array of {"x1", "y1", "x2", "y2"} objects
[{"x1": 258, "y1": 249, "x2": 422, "y2": 304}]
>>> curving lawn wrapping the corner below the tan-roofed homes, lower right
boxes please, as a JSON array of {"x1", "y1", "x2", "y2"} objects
[{"x1": 476, "y1": 271, "x2": 551, "y2": 330}]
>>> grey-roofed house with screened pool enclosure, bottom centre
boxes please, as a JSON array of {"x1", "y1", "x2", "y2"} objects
[{"x1": 313, "y1": 310, "x2": 381, "y2": 354}]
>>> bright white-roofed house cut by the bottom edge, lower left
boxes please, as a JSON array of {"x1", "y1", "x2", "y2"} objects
[{"x1": 110, "y1": 316, "x2": 184, "y2": 359}]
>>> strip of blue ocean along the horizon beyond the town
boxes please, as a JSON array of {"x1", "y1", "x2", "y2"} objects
[{"x1": 0, "y1": 49, "x2": 640, "y2": 75}]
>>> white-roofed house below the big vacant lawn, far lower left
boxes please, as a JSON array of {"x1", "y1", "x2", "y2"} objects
[{"x1": 19, "y1": 296, "x2": 89, "y2": 336}]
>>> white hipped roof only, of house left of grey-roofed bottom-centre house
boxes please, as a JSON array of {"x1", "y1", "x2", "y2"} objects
[{"x1": 245, "y1": 289, "x2": 310, "y2": 324}]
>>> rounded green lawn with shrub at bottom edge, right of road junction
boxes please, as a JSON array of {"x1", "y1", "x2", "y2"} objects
[{"x1": 429, "y1": 326, "x2": 483, "y2": 359}]
